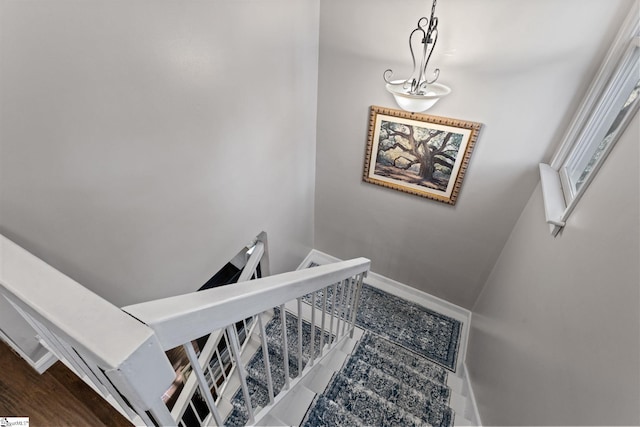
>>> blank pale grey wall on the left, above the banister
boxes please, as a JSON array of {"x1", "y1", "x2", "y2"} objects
[{"x1": 0, "y1": 0, "x2": 319, "y2": 305}]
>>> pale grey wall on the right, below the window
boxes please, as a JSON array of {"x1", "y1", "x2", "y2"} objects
[{"x1": 467, "y1": 114, "x2": 640, "y2": 425}]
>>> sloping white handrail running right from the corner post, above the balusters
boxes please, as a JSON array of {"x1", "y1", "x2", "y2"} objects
[{"x1": 122, "y1": 258, "x2": 371, "y2": 349}]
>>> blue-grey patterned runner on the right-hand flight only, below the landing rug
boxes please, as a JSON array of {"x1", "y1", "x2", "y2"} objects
[{"x1": 303, "y1": 333, "x2": 453, "y2": 427}]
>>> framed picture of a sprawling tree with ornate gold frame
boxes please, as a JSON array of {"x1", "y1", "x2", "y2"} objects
[{"x1": 363, "y1": 105, "x2": 482, "y2": 205}]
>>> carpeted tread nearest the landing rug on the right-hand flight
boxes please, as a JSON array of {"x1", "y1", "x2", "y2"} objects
[{"x1": 353, "y1": 333, "x2": 447, "y2": 385}]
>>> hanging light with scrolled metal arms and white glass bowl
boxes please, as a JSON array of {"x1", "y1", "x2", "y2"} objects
[{"x1": 383, "y1": 0, "x2": 451, "y2": 113}]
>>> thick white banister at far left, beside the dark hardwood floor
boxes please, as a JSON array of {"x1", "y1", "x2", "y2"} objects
[{"x1": 0, "y1": 235, "x2": 174, "y2": 422}]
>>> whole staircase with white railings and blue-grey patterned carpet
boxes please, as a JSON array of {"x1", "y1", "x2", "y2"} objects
[{"x1": 0, "y1": 233, "x2": 478, "y2": 427}]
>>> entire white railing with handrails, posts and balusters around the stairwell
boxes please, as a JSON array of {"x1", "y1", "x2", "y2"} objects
[{"x1": 0, "y1": 233, "x2": 370, "y2": 425}]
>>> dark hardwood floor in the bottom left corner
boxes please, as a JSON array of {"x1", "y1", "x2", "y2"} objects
[{"x1": 0, "y1": 341, "x2": 131, "y2": 426}]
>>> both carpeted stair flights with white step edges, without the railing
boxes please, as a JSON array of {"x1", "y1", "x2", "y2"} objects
[{"x1": 215, "y1": 282, "x2": 474, "y2": 427}]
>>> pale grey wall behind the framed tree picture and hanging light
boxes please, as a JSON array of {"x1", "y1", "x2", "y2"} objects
[{"x1": 315, "y1": 0, "x2": 633, "y2": 308}]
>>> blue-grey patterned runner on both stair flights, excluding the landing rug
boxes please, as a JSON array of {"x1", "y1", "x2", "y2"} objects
[{"x1": 225, "y1": 309, "x2": 454, "y2": 427}]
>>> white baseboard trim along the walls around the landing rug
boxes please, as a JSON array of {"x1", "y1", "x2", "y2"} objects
[{"x1": 298, "y1": 249, "x2": 471, "y2": 375}]
